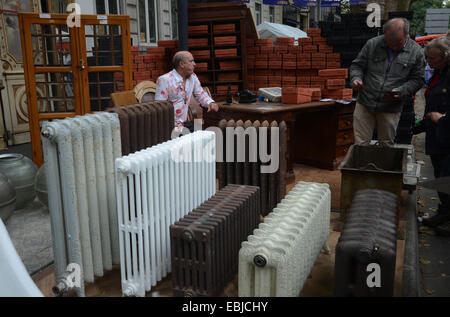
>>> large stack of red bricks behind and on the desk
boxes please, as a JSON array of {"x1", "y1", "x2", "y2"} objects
[{"x1": 247, "y1": 29, "x2": 352, "y2": 103}]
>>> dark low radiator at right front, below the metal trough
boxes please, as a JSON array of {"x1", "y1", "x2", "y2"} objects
[{"x1": 334, "y1": 189, "x2": 398, "y2": 297}]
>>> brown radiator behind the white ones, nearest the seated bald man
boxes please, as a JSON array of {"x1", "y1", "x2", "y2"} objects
[{"x1": 109, "y1": 101, "x2": 174, "y2": 155}]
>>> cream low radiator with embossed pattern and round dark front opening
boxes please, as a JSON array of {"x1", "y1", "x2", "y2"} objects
[{"x1": 238, "y1": 182, "x2": 331, "y2": 297}]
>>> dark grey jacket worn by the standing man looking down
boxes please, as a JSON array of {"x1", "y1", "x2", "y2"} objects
[{"x1": 350, "y1": 35, "x2": 425, "y2": 113}]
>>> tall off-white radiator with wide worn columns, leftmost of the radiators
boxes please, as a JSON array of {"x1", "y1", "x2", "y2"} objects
[{"x1": 42, "y1": 113, "x2": 121, "y2": 296}]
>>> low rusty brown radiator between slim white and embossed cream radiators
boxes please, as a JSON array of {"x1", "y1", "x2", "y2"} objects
[{"x1": 170, "y1": 185, "x2": 260, "y2": 297}]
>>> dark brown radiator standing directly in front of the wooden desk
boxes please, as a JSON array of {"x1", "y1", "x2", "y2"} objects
[{"x1": 218, "y1": 120, "x2": 287, "y2": 216}]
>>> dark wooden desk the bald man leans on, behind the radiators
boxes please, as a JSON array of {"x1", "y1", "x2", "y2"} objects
[{"x1": 203, "y1": 101, "x2": 355, "y2": 171}]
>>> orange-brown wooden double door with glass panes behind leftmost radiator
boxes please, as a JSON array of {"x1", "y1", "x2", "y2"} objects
[{"x1": 19, "y1": 13, "x2": 132, "y2": 166}]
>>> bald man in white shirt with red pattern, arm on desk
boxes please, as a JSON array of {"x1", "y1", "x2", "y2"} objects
[{"x1": 155, "y1": 51, "x2": 219, "y2": 132}]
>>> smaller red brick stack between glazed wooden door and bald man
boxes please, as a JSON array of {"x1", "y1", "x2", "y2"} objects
[{"x1": 131, "y1": 40, "x2": 178, "y2": 86}]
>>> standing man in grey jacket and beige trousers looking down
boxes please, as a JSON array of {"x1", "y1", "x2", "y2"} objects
[{"x1": 350, "y1": 18, "x2": 425, "y2": 146}]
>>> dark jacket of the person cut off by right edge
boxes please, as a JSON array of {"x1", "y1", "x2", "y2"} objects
[{"x1": 425, "y1": 66, "x2": 450, "y2": 155}]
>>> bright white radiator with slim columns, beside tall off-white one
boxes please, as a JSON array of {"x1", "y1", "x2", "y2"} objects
[{"x1": 115, "y1": 131, "x2": 216, "y2": 296}]
